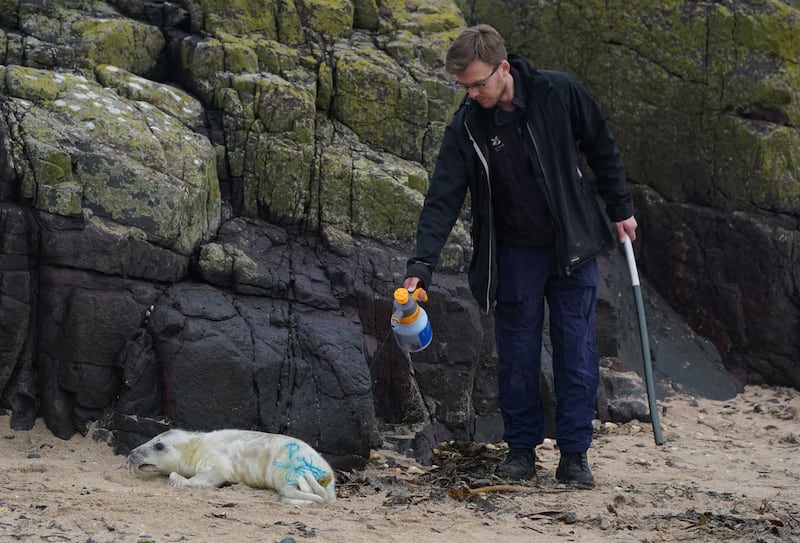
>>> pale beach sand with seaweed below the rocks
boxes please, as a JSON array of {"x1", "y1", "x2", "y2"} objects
[{"x1": 0, "y1": 386, "x2": 800, "y2": 543}]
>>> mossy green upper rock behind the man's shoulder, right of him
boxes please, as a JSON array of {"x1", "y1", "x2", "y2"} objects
[{"x1": 472, "y1": 0, "x2": 800, "y2": 217}]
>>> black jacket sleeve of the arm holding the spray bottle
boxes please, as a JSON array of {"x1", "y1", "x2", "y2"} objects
[{"x1": 406, "y1": 121, "x2": 467, "y2": 288}]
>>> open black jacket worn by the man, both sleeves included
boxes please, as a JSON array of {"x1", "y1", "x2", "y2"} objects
[{"x1": 406, "y1": 55, "x2": 633, "y2": 312}]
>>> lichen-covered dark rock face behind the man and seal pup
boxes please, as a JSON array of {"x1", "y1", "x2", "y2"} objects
[{"x1": 0, "y1": 0, "x2": 788, "y2": 466}]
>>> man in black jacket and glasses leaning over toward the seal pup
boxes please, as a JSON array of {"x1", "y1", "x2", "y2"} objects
[{"x1": 403, "y1": 25, "x2": 637, "y2": 487}]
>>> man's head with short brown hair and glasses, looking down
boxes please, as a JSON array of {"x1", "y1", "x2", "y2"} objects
[{"x1": 444, "y1": 25, "x2": 514, "y2": 108}]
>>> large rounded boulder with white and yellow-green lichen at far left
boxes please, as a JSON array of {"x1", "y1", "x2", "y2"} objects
[{"x1": 4, "y1": 66, "x2": 220, "y2": 255}]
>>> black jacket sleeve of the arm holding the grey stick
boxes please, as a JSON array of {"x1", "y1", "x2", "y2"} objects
[{"x1": 568, "y1": 76, "x2": 633, "y2": 222}]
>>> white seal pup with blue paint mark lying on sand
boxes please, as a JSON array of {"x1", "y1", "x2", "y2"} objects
[{"x1": 128, "y1": 429, "x2": 336, "y2": 505}]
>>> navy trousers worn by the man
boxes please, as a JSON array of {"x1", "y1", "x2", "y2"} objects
[{"x1": 495, "y1": 246, "x2": 600, "y2": 453}]
